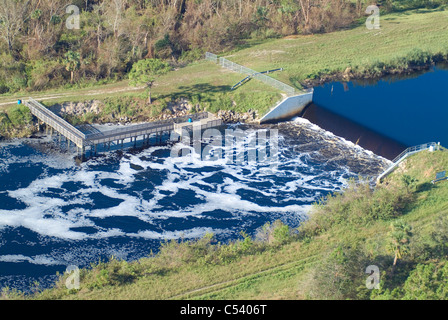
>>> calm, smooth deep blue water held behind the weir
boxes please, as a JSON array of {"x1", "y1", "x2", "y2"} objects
[{"x1": 313, "y1": 67, "x2": 448, "y2": 146}]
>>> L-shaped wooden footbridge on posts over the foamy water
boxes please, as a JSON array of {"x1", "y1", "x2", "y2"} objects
[{"x1": 23, "y1": 98, "x2": 222, "y2": 154}]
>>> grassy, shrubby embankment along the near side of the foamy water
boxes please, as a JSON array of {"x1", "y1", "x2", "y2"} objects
[{"x1": 3, "y1": 146, "x2": 448, "y2": 299}]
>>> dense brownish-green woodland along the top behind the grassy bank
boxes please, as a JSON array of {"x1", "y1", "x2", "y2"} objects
[{"x1": 0, "y1": 0, "x2": 447, "y2": 93}]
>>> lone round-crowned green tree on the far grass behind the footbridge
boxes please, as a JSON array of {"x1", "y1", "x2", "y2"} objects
[{"x1": 129, "y1": 59, "x2": 171, "y2": 104}]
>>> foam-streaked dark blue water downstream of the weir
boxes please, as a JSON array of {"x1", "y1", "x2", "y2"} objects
[{"x1": 0, "y1": 119, "x2": 387, "y2": 291}]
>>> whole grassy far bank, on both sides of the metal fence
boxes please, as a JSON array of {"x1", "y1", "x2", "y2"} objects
[{"x1": 0, "y1": 8, "x2": 448, "y2": 136}]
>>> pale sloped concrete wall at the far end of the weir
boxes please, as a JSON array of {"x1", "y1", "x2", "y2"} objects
[{"x1": 260, "y1": 90, "x2": 314, "y2": 123}]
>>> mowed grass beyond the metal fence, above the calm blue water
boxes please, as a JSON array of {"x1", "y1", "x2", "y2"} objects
[{"x1": 227, "y1": 9, "x2": 448, "y2": 85}]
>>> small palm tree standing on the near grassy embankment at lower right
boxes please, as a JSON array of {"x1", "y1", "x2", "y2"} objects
[{"x1": 388, "y1": 220, "x2": 412, "y2": 267}]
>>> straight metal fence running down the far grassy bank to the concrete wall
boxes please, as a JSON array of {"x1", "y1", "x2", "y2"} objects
[{"x1": 205, "y1": 52, "x2": 296, "y2": 96}]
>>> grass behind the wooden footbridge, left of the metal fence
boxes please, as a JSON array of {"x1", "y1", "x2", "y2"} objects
[{"x1": 0, "y1": 60, "x2": 284, "y2": 115}]
